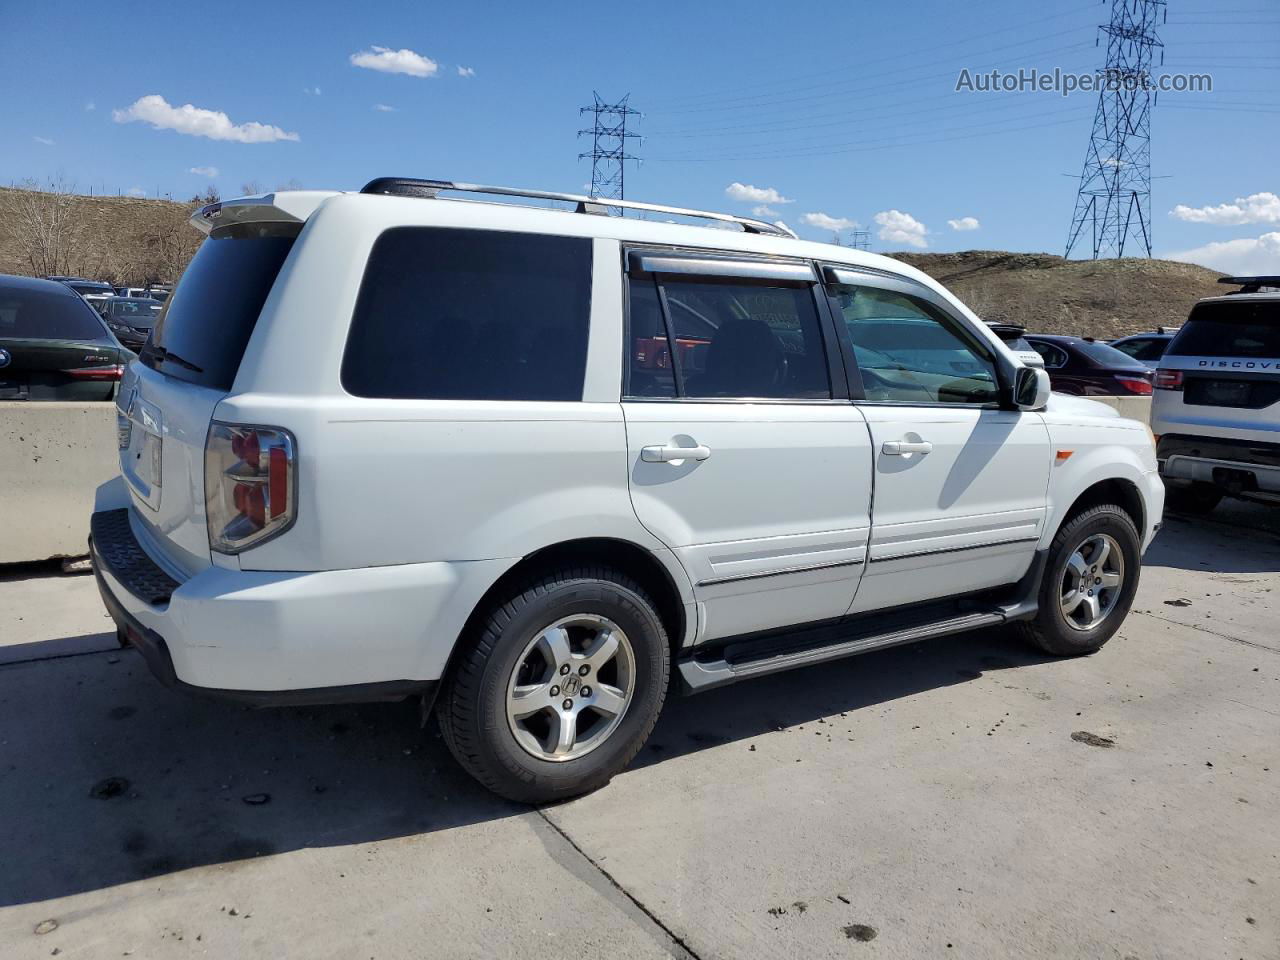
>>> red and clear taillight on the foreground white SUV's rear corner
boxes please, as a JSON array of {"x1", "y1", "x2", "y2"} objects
[{"x1": 205, "y1": 422, "x2": 297, "y2": 553}]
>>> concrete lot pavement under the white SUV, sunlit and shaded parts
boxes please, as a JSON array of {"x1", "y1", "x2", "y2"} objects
[{"x1": 0, "y1": 504, "x2": 1280, "y2": 960}]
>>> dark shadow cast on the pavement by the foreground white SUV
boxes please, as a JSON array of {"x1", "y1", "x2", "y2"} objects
[{"x1": 0, "y1": 631, "x2": 1041, "y2": 905}]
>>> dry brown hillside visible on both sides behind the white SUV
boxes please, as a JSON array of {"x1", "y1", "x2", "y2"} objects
[{"x1": 0, "y1": 188, "x2": 1222, "y2": 338}]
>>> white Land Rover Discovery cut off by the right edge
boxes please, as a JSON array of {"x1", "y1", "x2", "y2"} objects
[{"x1": 1151, "y1": 276, "x2": 1280, "y2": 513}]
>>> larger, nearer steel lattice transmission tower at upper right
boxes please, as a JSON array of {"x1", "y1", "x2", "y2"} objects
[{"x1": 1066, "y1": 0, "x2": 1167, "y2": 260}]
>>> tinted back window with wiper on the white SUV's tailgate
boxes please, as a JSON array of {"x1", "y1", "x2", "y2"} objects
[{"x1": 141, "y1": 224, "x2": 298, "y2": 390}]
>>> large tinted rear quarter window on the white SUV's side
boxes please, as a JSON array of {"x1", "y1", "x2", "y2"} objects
[{"x1": 343, "y1": 227, "x2": 591, "y2": 401}]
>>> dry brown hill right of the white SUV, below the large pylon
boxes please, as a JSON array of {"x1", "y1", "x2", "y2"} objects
[{"x1": 890, "y1": 250, "x2": 1229, "y2": 339}]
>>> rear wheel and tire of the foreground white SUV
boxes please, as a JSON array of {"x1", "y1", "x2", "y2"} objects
[{"x1": 436, "y1": 566, "x2": 671, "y2": 804}]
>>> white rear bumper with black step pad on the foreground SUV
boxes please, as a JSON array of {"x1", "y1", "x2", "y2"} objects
[{"x1": 90, "y1": 509, "x2": 509, "y2": 705}]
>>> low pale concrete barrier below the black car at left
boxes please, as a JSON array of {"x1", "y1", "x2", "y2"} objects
[{"x1": 0, "y1": 402, "x2": 119, "y2": 563}]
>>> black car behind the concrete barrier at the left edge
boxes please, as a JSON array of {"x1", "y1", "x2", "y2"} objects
[{"x1": 0, "y1": 274, "x2": 129, "y2": 401}]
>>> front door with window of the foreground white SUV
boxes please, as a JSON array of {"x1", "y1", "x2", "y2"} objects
[{"x1": 827, "y1": 269, "x2": 1051, "y2": 612}]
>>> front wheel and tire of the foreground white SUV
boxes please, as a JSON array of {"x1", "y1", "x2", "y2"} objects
[{"x1": 1018, "y1": 503, "x2": 1142, "y2": 657}]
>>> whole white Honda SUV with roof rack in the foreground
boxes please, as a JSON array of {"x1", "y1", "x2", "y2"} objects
[{"x1": 91, "y1": 179, "x2": 1164, "y2": 801}]
